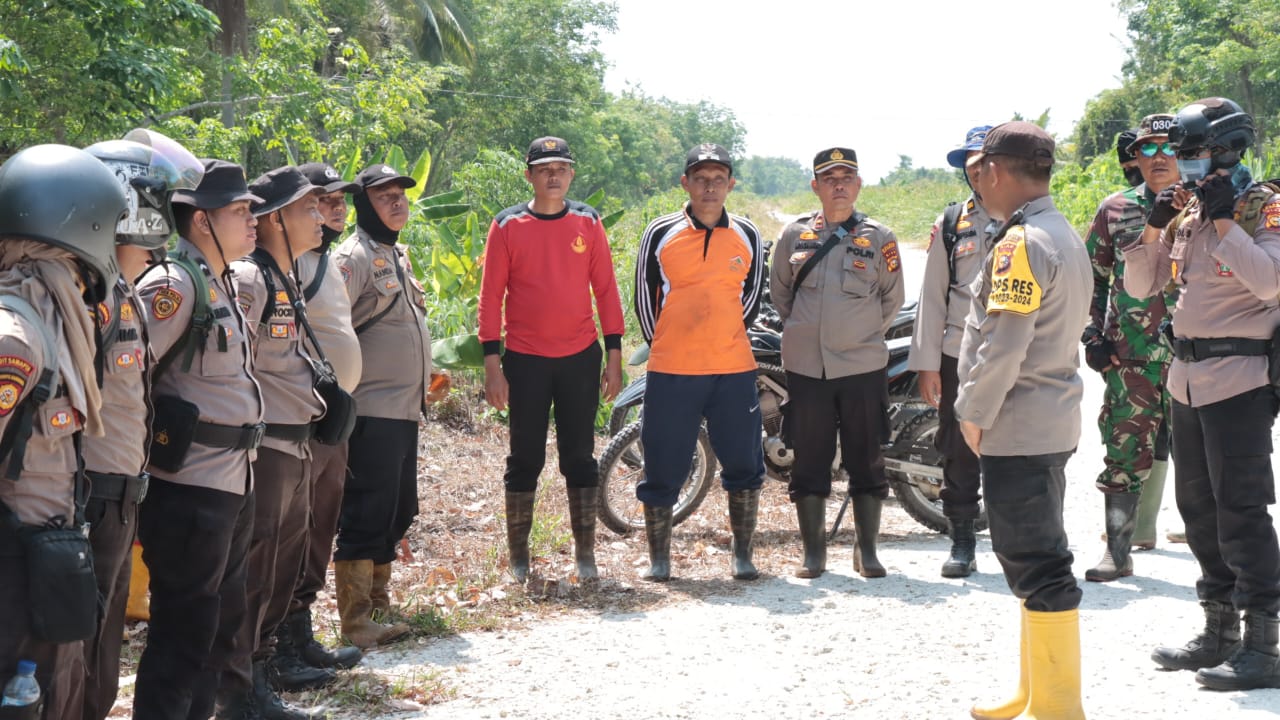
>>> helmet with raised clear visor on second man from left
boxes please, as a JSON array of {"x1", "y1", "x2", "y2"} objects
[{"x1": 84, "y1": 129, "x2": 205, "y2": 250}]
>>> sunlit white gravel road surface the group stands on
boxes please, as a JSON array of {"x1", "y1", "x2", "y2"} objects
[{"x1": 355, "y1": 243, "x2": 1280, "y2": 720}]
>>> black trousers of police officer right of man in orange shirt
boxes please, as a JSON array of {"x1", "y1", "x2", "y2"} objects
[{"x1": 786, "y1": 368, "x2": 888, "y2": 502}]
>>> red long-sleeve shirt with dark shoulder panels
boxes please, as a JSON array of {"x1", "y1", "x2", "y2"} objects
[{"x1": 479, "y1": 200, "x2": 623, "y2": 357}]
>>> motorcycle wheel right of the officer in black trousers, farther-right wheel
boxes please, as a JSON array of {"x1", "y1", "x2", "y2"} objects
[{"x1": 884, "y1": 407, "x2": 987, "y2": 533}]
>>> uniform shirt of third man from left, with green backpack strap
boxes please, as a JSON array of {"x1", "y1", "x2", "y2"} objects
[{"x1": 137, "y1": 237, "x2": 262, "y2": 495}]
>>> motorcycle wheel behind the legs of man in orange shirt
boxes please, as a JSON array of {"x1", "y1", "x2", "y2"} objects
[{"x1": 599, "y1": 423, "x2": 716, "y2": 536}]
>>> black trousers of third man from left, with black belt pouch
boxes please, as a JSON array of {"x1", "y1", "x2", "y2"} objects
[{"x1": 133, "y1": 478, "x2": 253, "y2": 720}]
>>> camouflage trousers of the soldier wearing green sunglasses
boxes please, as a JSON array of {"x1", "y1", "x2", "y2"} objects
[{"x1": 1096, "y1": 363, "x2": 1169, "y2": 495}]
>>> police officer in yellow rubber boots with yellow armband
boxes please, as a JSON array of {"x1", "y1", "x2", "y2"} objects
[{"x1": 955, "y1": 120, "x2": 1092, "y2": 720}]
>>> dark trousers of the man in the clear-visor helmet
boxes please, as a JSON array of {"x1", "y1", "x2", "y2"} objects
[{"x1": 83, "y1": 498, "x2": 138, "y2": 720}]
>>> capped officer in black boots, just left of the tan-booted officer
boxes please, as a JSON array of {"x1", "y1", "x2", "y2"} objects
[{"x1": 275, "y1": 163, "x2": 361, "y2": 667}]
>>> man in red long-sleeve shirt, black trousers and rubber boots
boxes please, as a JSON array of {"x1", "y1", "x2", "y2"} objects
[{"x1": 479, "y1": 137, "x2": 623, "y2": 582}]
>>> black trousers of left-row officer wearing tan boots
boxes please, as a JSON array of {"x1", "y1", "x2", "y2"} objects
[{"x1": 333, "y1": 418, "x2": 417, "y2": 565}]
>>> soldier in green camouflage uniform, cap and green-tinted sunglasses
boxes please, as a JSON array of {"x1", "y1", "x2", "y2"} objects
[{"x1": 1080, "y1": 114, "x2": 1178, "y2": 583}]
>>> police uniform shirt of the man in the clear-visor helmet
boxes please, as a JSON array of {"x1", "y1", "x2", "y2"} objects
[{"x1": 83, "y1": 278, "x2": 151, "y2": 475}]
